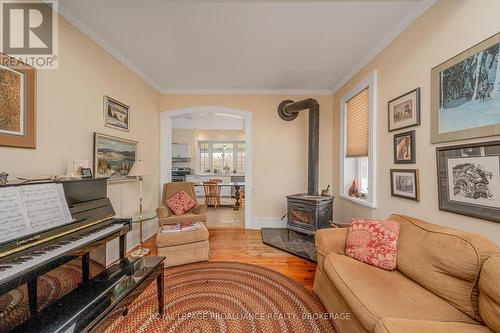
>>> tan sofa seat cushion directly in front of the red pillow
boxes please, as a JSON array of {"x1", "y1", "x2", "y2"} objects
[{"x1": 323, "y1": 254, "x2": 476, "y2": 332}]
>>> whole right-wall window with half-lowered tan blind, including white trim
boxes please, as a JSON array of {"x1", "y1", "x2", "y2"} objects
[{"x1": 339, "y1": 71, "x2": 377, "y2": 208}]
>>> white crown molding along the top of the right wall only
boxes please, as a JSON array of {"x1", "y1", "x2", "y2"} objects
[{"x1": 332, "y1": 0, "x2": 437, "y2": 94}]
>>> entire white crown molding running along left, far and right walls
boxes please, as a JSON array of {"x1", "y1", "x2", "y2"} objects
[{"x1": 53, "y1": 0, "x2": 437, "y2": 96}]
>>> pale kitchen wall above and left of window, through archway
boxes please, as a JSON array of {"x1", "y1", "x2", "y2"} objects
[{"x1": 172, "y1": 128, "x2": 245, "y2": 173}]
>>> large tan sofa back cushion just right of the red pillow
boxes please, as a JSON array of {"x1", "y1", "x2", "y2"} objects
[{"x1": 389, "y1": 215, "x2": 498, "y2": 321}]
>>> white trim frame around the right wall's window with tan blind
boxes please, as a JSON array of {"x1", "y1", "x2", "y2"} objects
[{"x1": 339, "y1": 70, "x2": 377, "y2": 208}]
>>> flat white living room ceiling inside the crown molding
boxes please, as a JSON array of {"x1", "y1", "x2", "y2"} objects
[{"x1": 59, "y1": 0, "x2": 435, "y2": 94}]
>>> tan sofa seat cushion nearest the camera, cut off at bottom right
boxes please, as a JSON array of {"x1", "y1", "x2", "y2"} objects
[{"x1": 374, "y1": 318, "x2": 493, "y2": 333}]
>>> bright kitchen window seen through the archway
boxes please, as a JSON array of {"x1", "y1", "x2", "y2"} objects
[{"x1": 198, "y1": 141, "x2": 245, "y2": 174}]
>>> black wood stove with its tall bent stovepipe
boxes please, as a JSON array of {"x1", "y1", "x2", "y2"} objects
[{"x1": 278, "y1": 98, "x2": 333, "y2": 235}]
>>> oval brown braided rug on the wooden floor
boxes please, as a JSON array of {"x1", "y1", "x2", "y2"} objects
[{"x1": 106, "y1": 262, "x2": 335, "y2": 333}]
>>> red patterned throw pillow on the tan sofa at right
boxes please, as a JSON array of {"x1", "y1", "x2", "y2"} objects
[{"x1": 345, "y1": 218, "x2": 399, "y2": 270}]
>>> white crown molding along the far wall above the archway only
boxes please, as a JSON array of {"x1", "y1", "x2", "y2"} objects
[{"x1": 161, "y1": 89, "x2": 332, "y2": 96}]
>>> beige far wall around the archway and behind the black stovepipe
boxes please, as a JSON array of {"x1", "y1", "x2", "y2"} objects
[{"x1": 161, "y1": 95, "x2": 333, "y2": 218}]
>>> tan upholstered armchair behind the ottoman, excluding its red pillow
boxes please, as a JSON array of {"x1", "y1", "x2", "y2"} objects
[{"x1": 156, "y1": 182, "x2": 207, "y2": 226}]
